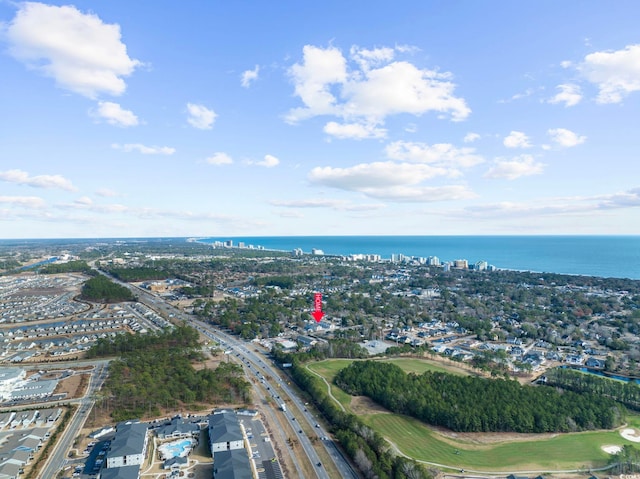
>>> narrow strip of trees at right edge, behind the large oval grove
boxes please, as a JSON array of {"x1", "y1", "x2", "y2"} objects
[{"x1": 545, "y1": 368, "x2": 640, "y2": 411}]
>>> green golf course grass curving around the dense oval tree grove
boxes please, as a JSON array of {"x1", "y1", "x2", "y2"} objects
[{"x1": 309, "y1": 358, "x2": 640, "y2": 472}]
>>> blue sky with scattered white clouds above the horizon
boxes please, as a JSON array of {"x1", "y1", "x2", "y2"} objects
[{"x1": 0, "y1": 0, "x2": 640, "y2": 239}]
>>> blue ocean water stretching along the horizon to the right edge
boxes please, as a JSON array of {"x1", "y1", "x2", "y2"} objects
[{"x1": 199, "y1": 236, "x2": 640, "y2": 279}]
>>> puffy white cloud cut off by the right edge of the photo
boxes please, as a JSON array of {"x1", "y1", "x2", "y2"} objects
[{"x1": 577, "y1": 44, "x2": 640, "y2": 103}]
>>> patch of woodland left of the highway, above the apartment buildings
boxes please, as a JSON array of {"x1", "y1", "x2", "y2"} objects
[{"x1": 88, "y1": 326, "x2": 250, "y2": 421}]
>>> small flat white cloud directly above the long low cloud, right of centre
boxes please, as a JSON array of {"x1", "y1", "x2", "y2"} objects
[{"x1": 385, "y1": 141, "x2": 484, "y2": 171}]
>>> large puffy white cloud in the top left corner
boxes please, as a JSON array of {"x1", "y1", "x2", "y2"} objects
[{"x1": 6, "y1": 2, "x2": 140, "y2": 98}]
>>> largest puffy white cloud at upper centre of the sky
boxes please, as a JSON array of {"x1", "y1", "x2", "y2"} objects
[{"x1": 287, "y1": 45, "x2": 470, "y2": 124}]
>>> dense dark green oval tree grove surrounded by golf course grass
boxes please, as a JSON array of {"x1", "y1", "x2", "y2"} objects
[{"x1": 335, "y1": 361, "x2": 624, "y2": 433}]
